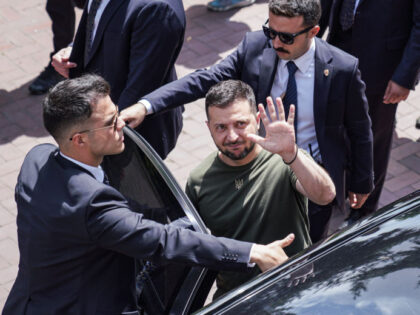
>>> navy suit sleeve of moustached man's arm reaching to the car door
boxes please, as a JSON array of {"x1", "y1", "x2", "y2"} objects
[{"x1": 144, "y1": 37, "x2": 247, "y2": 112}]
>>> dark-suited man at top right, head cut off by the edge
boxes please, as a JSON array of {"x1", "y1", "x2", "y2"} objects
[{"x1": 320, "y1": 0, "x2": 420, "y2": 217}]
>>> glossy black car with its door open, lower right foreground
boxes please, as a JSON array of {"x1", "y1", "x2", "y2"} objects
[{"x1": 105, "y1": 127, "x2": 420, "y2": 315}]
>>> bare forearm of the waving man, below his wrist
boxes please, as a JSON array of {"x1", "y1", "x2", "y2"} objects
[{"x1": 286, "y1": 150, "x2": 335, "y2": 205}]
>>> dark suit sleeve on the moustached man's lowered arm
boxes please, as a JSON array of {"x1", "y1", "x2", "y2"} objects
[{"x1": 345, "y1": 62, "x2": 373, "y2": 193}]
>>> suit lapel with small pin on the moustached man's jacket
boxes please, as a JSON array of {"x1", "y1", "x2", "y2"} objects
[{"x1": 314, "y1": 38, "x2": 334, "y2": 139}]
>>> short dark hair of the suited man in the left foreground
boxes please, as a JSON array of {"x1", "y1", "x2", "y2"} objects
[{"x1": 43, "y1": 74, "x2": 110, "y2": 142}]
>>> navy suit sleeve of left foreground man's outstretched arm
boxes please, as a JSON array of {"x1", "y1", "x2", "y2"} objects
[{"x1": 86, "y1": 187, "x2": 252, "y2": 270}]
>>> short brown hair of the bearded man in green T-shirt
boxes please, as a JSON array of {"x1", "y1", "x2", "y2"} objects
[{"x1": 206, "y1": 80, "x2": 257, "y2": 119}]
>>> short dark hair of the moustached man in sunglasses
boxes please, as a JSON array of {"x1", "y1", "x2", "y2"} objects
[{"x1": 268, "y1": 0, "x2": 321, "y2": 26}]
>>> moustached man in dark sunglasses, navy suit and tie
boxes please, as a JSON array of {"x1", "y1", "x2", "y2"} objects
[{"x1": 121, "y1": 0, "x2": 373, "y2": 242}]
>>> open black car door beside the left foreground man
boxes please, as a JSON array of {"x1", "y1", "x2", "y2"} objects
[{"x1": 103, "y1": 127, "x2": 214, "y2": 315}]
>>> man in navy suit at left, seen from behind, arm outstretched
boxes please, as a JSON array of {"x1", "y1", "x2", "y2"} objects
[{"x1": 3, "y1": 75, "x2": 294, "y2": 315}]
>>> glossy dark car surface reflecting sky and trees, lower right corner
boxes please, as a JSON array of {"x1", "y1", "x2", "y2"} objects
[{"x1": 200, "y1": 201, "x2": 420, "y2": 314}]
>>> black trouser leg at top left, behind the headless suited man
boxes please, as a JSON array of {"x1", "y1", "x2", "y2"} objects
[{"x1": 46, "y1": 0, "x2": 86, "y2": 55}]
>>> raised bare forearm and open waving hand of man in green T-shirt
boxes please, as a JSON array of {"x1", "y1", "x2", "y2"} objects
[{"x1": 247, "y1": 97, "x2": 335, "y2": 205}]
